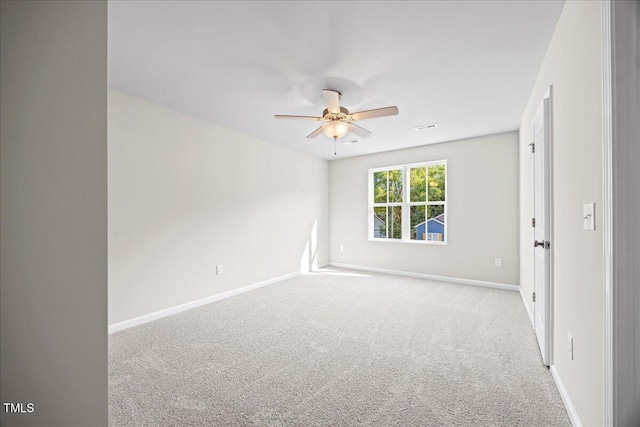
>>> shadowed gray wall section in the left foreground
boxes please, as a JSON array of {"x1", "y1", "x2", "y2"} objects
[{"x1": 0, "y1": 1, "x2": 108, "y2": 426}]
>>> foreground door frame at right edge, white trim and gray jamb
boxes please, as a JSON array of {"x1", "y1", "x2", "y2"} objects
[{"x1": 602, "y1": 0, "x2": 640, "y2": 427}]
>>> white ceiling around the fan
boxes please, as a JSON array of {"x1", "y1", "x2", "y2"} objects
[{"x1": 109, "y1": 0, "x2": 563, "y2": 159}]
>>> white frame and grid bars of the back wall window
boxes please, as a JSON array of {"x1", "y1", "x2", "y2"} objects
[{"x1": 367, "y1": 159, "x2": 449, "y2": 245}]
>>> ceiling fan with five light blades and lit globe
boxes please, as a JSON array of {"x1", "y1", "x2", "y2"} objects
[{"x1": 275, "y1": 89, "x2": 398, "y2": 141}]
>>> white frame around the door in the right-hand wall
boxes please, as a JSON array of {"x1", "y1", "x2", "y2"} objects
[{"x1": 531, "y1": 85, "x2": 555, "y2": 366}]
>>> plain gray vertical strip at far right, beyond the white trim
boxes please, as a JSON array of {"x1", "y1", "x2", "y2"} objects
[{"x1": 612, "y1": 1, "x2": 640, "y2": 427}]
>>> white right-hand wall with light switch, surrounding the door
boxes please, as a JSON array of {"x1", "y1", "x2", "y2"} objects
[{"x1": 520, "y1": 1, "x2": 604, "y2": 426}]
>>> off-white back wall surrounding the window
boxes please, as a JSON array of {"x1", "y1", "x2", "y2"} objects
[{"x1": 329, "y1": 132, "x2": 519, "y2": 284}]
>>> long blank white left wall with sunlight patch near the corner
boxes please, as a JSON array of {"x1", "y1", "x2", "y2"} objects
[{"x1": 109, "y1": 91, "x2": 329, "y2": 324}]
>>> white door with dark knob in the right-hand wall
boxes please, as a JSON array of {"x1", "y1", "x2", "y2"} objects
[{"x1": 531, "y1": 92, "x2": 551, "y2": 366}]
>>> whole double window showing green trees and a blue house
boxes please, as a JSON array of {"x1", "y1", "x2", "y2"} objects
[{"x1": 369, "y1": 160, "x2": 447, "y2": 243}]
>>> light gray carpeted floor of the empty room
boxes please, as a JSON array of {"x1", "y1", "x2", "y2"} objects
[{"x1": 109, "y1": 267, "x2": 570, "y2": 427}]
